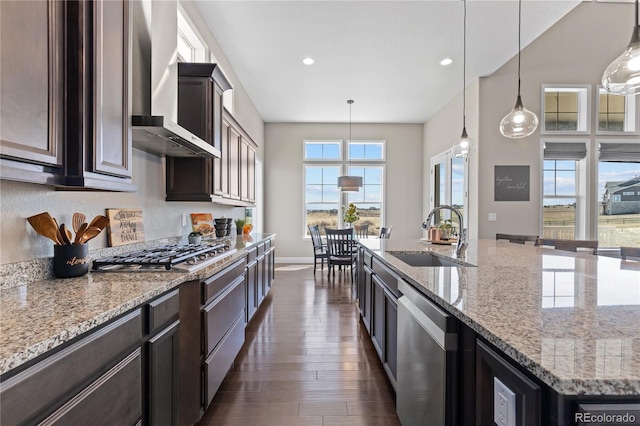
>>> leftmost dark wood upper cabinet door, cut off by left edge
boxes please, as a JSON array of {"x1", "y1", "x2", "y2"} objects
[{"x1": 0, "y1": 0, "x2": 65, "y2": 178}]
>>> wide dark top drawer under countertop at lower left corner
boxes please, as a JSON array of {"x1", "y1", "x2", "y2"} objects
[{"x1": 0, "y1": 309, "x2": 142, "y2": 424}]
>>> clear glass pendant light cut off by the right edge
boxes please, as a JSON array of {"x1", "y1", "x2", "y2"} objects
[{"x1": 602, "y1": 0, "x2": 640, "y2": 95}]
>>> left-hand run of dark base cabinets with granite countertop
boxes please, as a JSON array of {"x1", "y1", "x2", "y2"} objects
[{"x1": 0, "y1": 234, "x2": 275, "y2": 424}]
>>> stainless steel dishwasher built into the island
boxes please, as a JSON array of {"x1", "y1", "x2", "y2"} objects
[{"x1": 396, "y1": 280, "x2": 458, "y2": 426}]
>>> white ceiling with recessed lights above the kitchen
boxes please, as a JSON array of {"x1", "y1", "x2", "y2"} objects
[{"x1": 195, "y1": 0, "x2": 580, "y2": 123}]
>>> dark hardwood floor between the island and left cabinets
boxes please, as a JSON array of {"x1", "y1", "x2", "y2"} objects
[{"x1": 198, "y1": 265, "x2": 400, "y2": 426}]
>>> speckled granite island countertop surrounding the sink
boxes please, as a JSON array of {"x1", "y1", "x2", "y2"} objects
[{"x1": 361, "y1": 239, "x2": 640, "y2": 395}]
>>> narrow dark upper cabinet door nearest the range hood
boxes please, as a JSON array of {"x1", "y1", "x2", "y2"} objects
[{"x1": 87, "y1": 0, "x2": 133, "y2": 177}]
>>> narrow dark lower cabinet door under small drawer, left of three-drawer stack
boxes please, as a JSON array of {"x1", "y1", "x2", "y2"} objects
[{"x1": 145, "y1": 321, "x2": 180, "y2": 426}]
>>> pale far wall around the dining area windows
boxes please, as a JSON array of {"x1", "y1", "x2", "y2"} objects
[{"x1": 265, "y1": 123, "x2": 425, "y2": 258}]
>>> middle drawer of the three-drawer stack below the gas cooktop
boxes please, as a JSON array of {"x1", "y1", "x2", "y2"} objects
[{"x1": 202, "y1": 277, "x2": 245, "y2": 356}]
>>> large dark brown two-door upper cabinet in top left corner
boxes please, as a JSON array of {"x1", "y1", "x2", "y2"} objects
[{"x1": 0, "y1": 0, "x2": 136, "y2": 191}]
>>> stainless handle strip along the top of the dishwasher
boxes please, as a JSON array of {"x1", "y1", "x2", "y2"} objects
[{"x1": 398, "y1": 279, "x2": 458, "y2": 351}]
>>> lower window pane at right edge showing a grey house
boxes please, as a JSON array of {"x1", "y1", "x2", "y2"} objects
[{"x1": 598, "y1": 161, "x2": 640, "y2": 247}]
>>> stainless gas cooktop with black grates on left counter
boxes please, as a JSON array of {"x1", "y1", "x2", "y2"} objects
[{"x1": 93, "y1": 243, "x2": 235, "y2": 272}]
